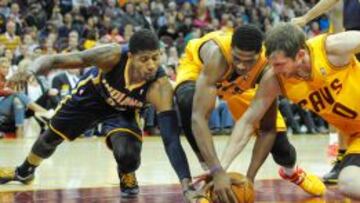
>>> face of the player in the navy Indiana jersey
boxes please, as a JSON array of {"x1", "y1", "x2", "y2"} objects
[{"x1": 132, "y1": 50, "x2": 160, "y2": 80}]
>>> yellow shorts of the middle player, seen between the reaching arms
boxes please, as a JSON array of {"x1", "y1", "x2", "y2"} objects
[{"x1": 225, "y1": 89, "x2": 286, "y2": 132}]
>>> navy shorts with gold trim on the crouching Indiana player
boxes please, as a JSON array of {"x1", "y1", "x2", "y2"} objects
[{"x1": 50, "y1": 78, "x2": 141, "y2": 140}]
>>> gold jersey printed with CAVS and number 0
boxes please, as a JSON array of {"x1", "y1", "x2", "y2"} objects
[{"x1": 278, "y1": 34, "x2": 360, "y2": 153}]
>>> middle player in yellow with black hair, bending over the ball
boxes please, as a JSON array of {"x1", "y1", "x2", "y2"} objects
[{"x1": 175, "y1": 25, "x2": 325, "y2": 202}]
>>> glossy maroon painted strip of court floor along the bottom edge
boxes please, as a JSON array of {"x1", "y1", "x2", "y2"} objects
[{"x1": 0, "y1": 180, "x2": 356, "y2": 203}]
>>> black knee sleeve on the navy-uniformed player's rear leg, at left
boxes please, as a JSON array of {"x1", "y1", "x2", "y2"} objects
[{"x1": 31, "y1": 130, "x2": 64, "y2": 159}]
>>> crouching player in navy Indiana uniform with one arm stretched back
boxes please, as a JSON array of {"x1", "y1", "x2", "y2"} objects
[{"x1": 0, "y1": 30, "x2": 194, "y2": 197}]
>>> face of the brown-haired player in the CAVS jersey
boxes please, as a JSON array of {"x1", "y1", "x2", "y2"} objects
[{"x1": 269, "y1": 51, "x2": 298, "y2": 78}]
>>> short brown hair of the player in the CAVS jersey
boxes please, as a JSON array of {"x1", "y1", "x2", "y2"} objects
[{"x1": 265, "y1": 23, "x2": 306, "y2": 58}]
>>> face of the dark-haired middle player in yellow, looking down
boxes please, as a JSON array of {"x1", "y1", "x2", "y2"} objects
[{"x1": 231, "y1": 47, "x2": 259, "y2": 75}]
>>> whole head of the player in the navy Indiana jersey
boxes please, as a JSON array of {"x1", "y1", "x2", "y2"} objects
[{"x1": 129, "y1": 29, "x2": 160, "y2": 80}]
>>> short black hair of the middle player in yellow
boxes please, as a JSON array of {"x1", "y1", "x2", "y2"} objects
[{"x1": 231, "y1": 25, "x2": 264, "y2": 53}]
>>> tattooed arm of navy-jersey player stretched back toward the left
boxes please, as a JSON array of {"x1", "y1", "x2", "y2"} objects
[{"x1": 28, "y1": 43, "x2": 121, "y2": 73}]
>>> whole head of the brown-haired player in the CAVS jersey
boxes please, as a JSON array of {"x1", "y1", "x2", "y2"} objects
[{"x1": 265, "y1": 23, "x2": 306, "y2": 77}]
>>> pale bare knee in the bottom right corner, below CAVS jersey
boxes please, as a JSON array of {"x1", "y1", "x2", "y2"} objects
[{"x1": 338, "y1": 165, "x2": 360, "y2": 199}]
